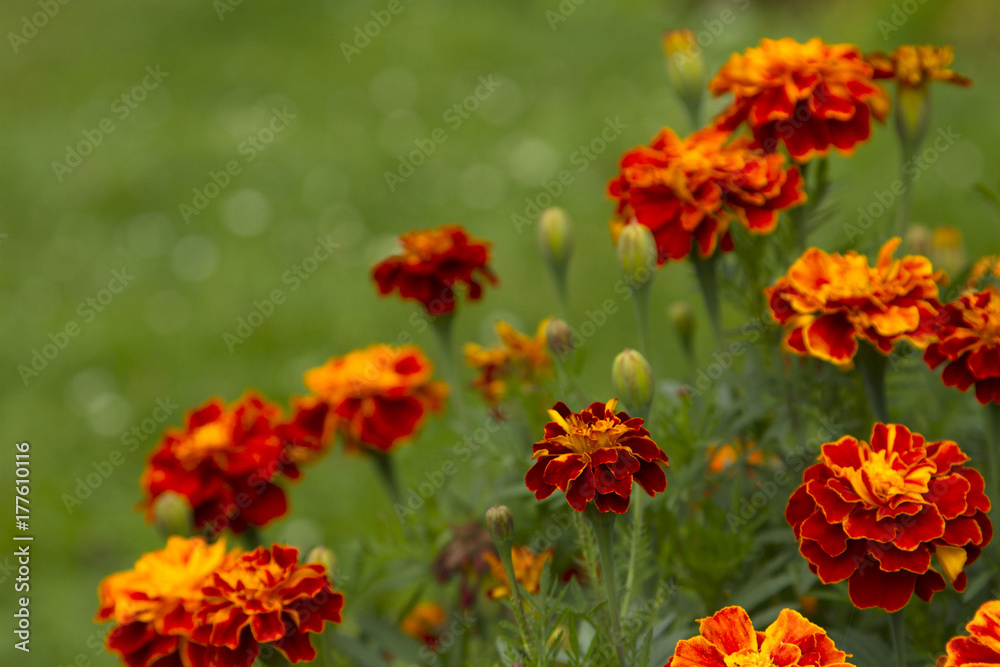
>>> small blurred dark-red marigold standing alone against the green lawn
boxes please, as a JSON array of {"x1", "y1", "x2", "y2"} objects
[{"x1": 372, "y1": 225, "x2": 497, "y2": 315}]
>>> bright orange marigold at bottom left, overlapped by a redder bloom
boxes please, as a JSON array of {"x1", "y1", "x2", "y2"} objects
[{"x1": 94, "y1": 537, "x2": 235, "y2": 667}]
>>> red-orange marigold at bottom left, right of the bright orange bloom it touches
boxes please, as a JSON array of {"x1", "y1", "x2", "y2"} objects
[{"x1": 187, "y1": 544, "x2": 344, "y2": 667}]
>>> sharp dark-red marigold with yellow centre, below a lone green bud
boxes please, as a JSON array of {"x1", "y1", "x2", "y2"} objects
[{"x1": 525, "y1": 398, "x2": 668, "y2": 514}]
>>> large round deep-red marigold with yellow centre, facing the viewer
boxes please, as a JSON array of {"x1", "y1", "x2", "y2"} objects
[{"x1": 785, "y1": 423, "x2": 993, "y2": 611}]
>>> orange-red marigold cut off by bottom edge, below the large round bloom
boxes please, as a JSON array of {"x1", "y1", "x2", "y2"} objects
[{"x1": 664, "y1": 607, "x2": 851, "y2": 667}]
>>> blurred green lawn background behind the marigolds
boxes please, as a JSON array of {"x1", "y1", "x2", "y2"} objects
[{"x1": 0, "y1": 0, "x2": 1000, "y2": 665}]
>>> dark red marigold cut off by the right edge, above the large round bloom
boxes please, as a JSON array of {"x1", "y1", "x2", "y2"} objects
[{"x1": 924, "y1": 285, "x2": 1000, "y2": 405}]
